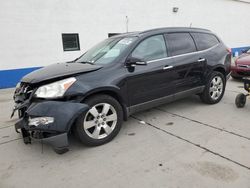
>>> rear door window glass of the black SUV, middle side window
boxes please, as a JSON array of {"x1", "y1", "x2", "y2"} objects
[{"x1": 166, "y1": 33, "x2": 196, "y2": 56}]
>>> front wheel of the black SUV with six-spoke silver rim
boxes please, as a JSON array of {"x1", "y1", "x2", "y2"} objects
[{"x1": 73, "y1": 95, "x2": 123, "y2": 146}]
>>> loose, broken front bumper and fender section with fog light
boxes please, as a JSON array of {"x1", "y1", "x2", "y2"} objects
[{"x1": 15, "y1": 101, "x2": 89, "y2": 154}]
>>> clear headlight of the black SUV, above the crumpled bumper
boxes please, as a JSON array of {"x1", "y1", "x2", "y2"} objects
[{"x1": 35, "y1": 77, "x2": 76, "y2": 98}]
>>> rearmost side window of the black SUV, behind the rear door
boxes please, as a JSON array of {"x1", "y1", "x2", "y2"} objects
[{"x1": 192, "y1": 33, "x2": 219, "y2": 51}]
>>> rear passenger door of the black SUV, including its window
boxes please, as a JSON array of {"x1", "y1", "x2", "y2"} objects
[{"x1": 165, "y1": 32, "x2": 206, "y2": 93}]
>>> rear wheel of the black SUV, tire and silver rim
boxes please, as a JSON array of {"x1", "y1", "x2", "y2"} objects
[{"x1": 200, "y1": 71, "x2": 226, "y2": 104}]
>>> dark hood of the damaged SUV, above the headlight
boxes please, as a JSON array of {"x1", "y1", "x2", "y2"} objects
[{"x1": 21, "y1": 62, "x2": 102, "y2": 84}]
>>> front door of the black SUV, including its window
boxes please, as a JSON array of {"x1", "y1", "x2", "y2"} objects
[{"x1": 127, "y1": 35, "x2": 176, "y2": 107}]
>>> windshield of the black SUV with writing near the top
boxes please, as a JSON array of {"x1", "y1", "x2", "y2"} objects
[{"x1": 75, "y1": 37, "x2": 136, "y2": 64}]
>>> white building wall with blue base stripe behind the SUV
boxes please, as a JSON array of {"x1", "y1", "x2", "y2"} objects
[{"x1": 0, "y1": 0, "x2": 250, "y2": 88}]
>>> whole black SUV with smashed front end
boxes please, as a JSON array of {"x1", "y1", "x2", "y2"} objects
[{"x1": 13, "y1": 28, "x2": 231, "y2": 153}]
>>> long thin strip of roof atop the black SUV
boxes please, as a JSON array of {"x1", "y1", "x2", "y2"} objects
[{"x1": 113, "y1": 27, "x2": 211, "y2": 38}]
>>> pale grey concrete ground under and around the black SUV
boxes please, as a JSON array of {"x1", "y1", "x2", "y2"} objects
[{"x1": 0, "y1": 80, "x2": 250, "y2": 188}]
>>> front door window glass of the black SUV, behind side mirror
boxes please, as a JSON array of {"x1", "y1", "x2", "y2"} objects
[{"x1": 132, "y1": 35, "x2": 167, "y2": 61}]
